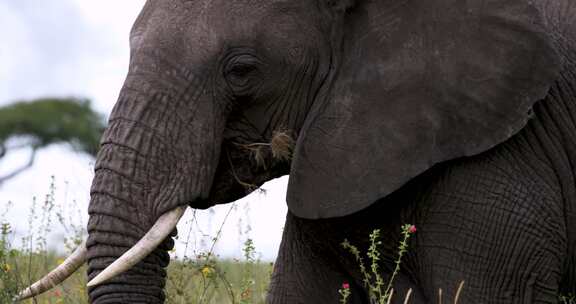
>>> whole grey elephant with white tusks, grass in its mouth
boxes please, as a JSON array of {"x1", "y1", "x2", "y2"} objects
[{"x1": 16, "y1": 0, "x2": 576, "y2": 304}]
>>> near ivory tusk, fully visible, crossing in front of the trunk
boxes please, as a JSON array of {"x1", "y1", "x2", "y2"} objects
[{"x1": 87, "y1": 206, "x2": 186, "y2": 287}]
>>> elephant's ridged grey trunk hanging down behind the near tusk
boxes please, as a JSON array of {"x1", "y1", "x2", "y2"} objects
[{"x1": 86, "y1": 67, "x2": 224, "y2": 304}]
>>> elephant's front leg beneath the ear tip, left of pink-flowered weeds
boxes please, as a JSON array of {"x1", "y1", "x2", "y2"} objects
[{"x1": 266, "y1": 212, "x2": 368, "y2": 304}]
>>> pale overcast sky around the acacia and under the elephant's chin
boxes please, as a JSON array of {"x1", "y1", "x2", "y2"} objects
[{"x1": 0, "y1": 0, "x2": 287, "y2": 260}]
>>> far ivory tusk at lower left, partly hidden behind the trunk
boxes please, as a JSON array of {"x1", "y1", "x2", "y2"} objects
[{"x1": 14, "y1": 240, "x2": 87, "y2": 302}]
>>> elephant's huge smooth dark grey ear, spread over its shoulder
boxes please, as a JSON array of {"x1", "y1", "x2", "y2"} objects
[{"x1": 287, "y1": 0, "x2": 560, "y2": 218}]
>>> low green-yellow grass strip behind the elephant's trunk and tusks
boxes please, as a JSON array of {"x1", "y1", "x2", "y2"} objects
[{"x1": 0, "y1": 246, "x2": 272, "y2": 304}]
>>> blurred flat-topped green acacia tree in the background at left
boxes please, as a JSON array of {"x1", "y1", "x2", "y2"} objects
[{"x1": 0, "y1": 98, "x2": 105, "y2": 185}]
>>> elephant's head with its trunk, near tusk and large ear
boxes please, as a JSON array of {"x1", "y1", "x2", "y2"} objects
[{"x1": 19, "y1": 0, "x2": 561, "y2": 303}]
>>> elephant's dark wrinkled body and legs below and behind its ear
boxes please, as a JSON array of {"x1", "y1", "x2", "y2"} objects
[{"x1": 268, "y1": 65, "x2": 576, "y2": 303}]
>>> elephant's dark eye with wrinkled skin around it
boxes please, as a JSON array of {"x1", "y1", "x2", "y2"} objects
[{"x1": 224, "y1": 55, "x2": 260, "y2": 95}]
